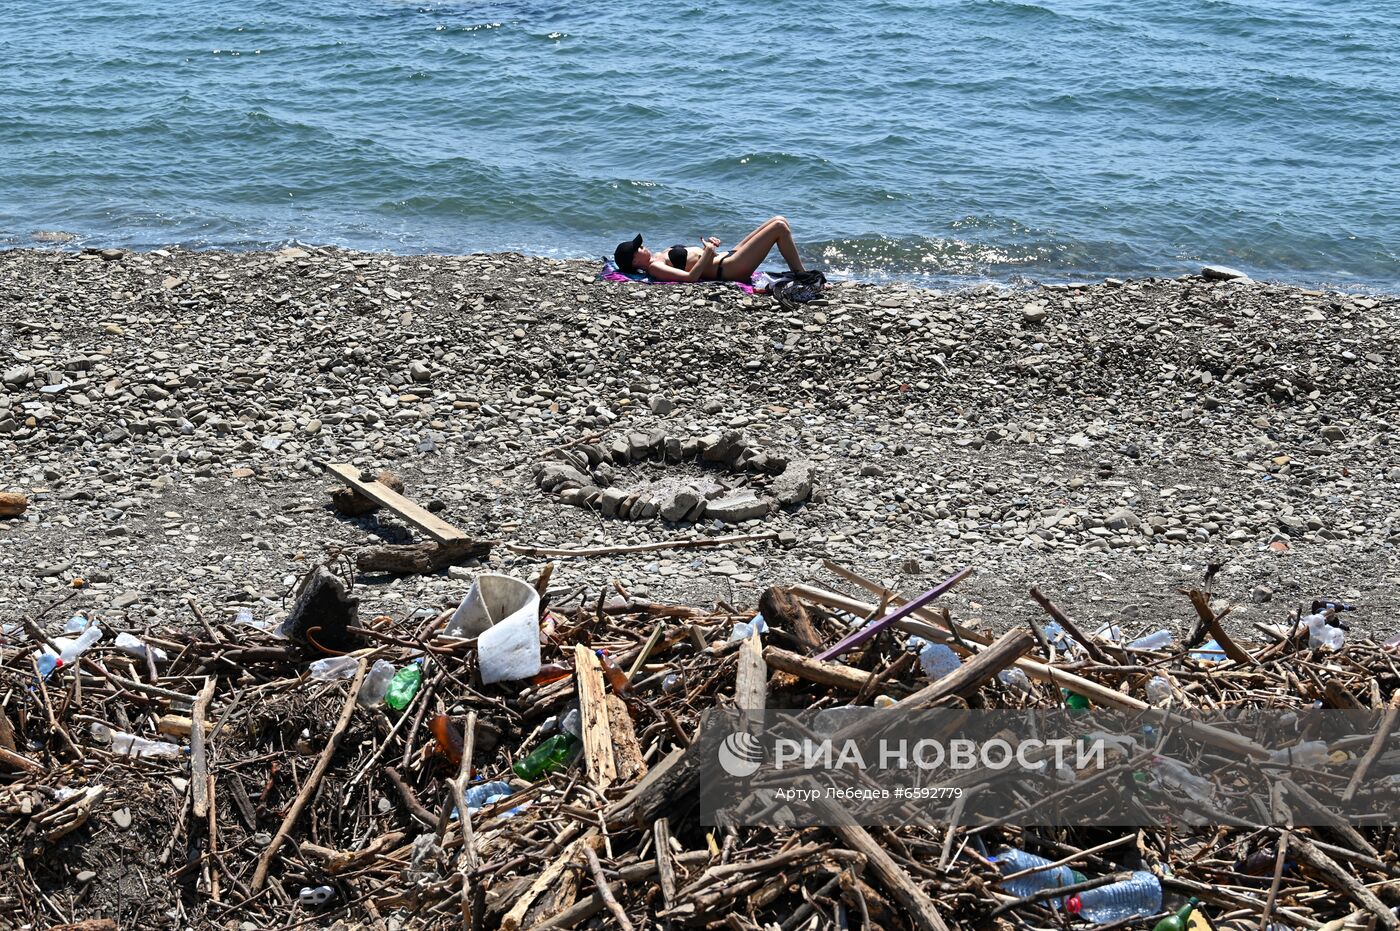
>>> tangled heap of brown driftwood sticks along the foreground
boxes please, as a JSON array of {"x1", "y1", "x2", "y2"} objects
[{"x1": 0, "y1": 554, "x2": 1400, "y2": 931}]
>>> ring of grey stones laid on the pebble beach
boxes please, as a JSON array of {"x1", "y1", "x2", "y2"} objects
[{"x1": 535, "y1": 430, "x2": 816, "y2": 524}]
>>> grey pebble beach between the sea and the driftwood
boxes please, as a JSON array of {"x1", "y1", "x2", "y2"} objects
[{"x1": 0, "y1": 239, "x2": 1400, "y2": 644}]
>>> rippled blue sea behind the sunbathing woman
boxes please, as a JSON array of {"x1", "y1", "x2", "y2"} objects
[{"x1": 0, "y1": 0, "x2": 1400, "y2": 291}]
